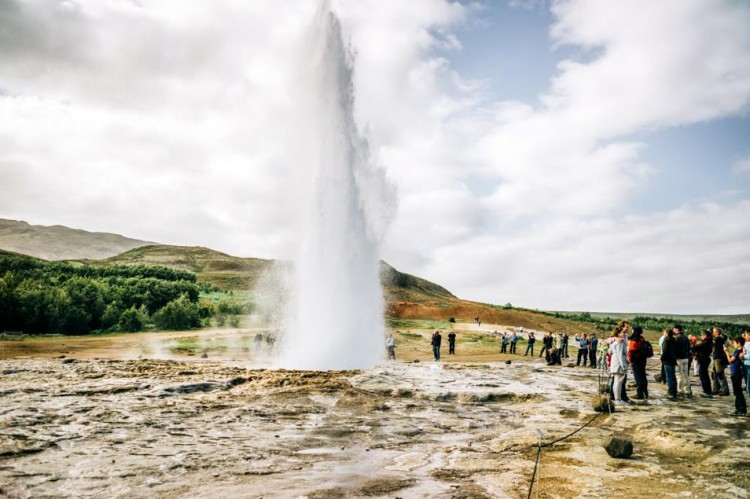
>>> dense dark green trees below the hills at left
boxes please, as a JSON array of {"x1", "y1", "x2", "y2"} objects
[{"x1": 0, "y1": 252, "x2": 242, "y2": 334}]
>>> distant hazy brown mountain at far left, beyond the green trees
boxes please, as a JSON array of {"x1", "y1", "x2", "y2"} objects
[{"x1": 0, "y1": 218, "x2": 153, "y2": 260}]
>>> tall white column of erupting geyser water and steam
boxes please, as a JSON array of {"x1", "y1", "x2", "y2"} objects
[{"x1": 278, "y1": 1, "x2": 393, "y2": 370}]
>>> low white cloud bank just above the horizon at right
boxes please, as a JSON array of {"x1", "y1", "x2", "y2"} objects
[{"x1": 424, "y1": 201, "x2": 750, "y2": 314}]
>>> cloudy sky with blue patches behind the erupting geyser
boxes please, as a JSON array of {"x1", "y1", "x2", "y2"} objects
[{"x1": 0, "y1": 0, "x2": 750, "y2": 314}]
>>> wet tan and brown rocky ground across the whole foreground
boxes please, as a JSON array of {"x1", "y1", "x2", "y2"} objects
[{"x1": 0, "y1": 359, "x2": 750, "y2": 498}]
